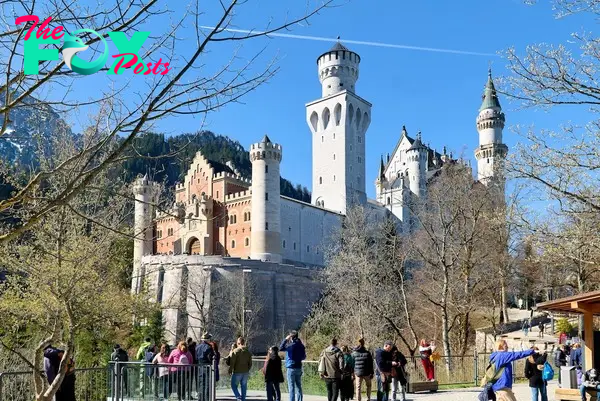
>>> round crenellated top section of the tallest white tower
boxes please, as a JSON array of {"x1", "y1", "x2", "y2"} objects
[{"x1": 317, "y1": 42, "x2": 360, "y2": 97}]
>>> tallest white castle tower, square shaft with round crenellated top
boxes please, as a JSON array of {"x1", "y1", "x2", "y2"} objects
[{"x1": 306, "y1": 42, "x2": 371, "y2": 214}]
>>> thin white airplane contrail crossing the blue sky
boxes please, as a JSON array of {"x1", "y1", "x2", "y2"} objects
[{"x1": 200, "y1": 26, "x2": 499, "y2": 57}]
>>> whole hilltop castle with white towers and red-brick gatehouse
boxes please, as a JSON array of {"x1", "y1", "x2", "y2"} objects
[{"x1": 132, "y1": 42, "x2": 508, "y2": 339}]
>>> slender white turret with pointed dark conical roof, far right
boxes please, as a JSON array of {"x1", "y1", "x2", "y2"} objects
[{"x1": 475, "y1": 69, "x2": 508, "y2": 189}]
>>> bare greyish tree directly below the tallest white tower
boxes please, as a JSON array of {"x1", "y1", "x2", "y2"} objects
[{"x1": 308, "y1": 206, "x2": 418, "y2": 355}]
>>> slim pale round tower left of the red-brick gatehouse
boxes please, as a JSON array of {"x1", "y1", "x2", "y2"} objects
[{"x1": 131, "y1": 175, "x2": 159, "y2": 294}]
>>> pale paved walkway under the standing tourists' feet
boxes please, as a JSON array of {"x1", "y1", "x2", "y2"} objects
[{"x1": 217, "y1": 381, "x2": 557, "y2": 401}]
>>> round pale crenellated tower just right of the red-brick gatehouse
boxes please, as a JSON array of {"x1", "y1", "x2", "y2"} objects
[{"x1": 250, "y1": 135, "x2": 282, "y2": 262}]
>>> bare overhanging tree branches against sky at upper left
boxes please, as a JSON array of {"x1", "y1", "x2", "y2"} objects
[{"x1": 0, "y1": 0, "x2": 332, "y2": 242}]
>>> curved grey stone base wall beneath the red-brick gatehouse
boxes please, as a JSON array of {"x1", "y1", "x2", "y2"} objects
[{"x1": 142, "y1": 255, "x2": 322, "y2": 352}]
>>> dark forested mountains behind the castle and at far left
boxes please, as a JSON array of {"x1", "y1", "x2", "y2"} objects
[{"x1": 0, "y1": 101, "x2": 310, "y2": 202}]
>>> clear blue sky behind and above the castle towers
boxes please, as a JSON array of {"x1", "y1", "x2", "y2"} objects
[{"x1": 65, "y1": 0, "x2": 594, "y2": 197}]
